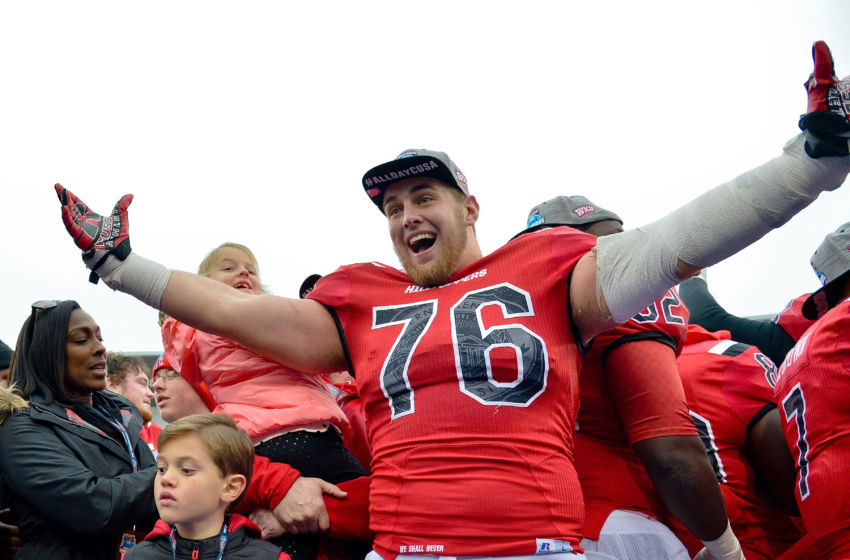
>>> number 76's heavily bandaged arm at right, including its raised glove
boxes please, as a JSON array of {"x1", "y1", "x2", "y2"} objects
[{"x1": 571, "y1": 42, "x2": 850, "y2": 339}]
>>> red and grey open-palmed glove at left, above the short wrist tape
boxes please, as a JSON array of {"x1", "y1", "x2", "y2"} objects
[{"x1": 55, "y1": 183, "x2": 133, "y2": 284}]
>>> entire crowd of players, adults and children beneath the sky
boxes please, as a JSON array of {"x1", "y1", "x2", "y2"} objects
[{"x1": 0, "y1": 42, "x2": 850, "y2": 560}]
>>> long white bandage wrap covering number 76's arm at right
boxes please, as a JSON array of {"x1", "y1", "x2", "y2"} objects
[{"x1": 596, "y1": 134, "x2": 850, "y2": 323}]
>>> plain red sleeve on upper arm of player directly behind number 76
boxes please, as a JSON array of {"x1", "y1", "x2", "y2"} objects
[{"x1": 605, "y1": 340, "x2": 697, "y2": 444}]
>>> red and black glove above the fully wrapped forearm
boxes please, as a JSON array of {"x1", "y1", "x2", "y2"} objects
[{"x1": 799, "y1": 41, "x2": 850, "y2": 158}]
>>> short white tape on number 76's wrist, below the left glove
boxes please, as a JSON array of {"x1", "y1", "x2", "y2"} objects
[{"x1": 86, "y1": 253, "x2": 171, "y2": 309}]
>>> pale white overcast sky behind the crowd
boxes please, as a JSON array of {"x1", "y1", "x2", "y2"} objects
[{"x1": 0, "y1": 0, "x2": 850, "y2": 351}]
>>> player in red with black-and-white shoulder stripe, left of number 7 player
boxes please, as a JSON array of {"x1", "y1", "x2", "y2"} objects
[{"x1": 678, "y1": 325, "x2": 801, "y2": 560}]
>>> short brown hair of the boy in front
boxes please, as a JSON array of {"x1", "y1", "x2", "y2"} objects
[{"x1": 157, "y1": 414, "x2": 254, "y2": 508}]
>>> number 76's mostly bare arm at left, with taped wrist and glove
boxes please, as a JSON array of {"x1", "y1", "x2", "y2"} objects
[{"x1": 56, "y1": 184, "x2": 347, "y2": 373}]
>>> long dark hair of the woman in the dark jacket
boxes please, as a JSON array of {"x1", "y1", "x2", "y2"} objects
[{"x1": 11, "y1": 300, "x2": 81, "y2": 404}]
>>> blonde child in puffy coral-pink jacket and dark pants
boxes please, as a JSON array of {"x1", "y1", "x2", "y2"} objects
[{"x1": 162, "y1": 243, "x2": 367, "y2": 560}]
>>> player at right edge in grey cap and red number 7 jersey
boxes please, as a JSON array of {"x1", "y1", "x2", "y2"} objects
[{"x1": 774, "y1": 222, "x2": 850, "y2": 560}]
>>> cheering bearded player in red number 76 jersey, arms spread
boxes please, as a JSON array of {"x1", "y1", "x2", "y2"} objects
[{"x1": 56, "y1": 43, "x2": 850, "y2": 560}]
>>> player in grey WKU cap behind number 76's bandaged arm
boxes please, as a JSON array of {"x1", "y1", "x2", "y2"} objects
[{"x1": 528, "y1": 196, "x2": 728, "y2": 560}]
